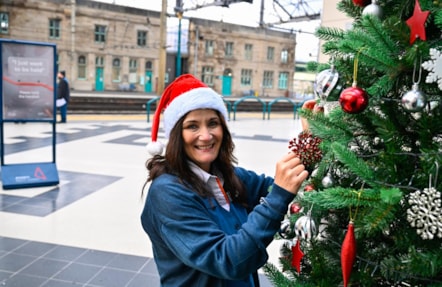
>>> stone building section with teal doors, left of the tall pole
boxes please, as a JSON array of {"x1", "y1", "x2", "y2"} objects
[{"x1": 0, "y1": 0, "x2": 160, "y2": 92}]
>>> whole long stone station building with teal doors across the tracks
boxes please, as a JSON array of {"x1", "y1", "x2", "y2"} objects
[{"x1": 0, "y1": 0, "x2": 296, "y2": 97}]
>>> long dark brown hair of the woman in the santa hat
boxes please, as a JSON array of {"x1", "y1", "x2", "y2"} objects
[{"x1": 143, "y1": 110, "x2": 247, "y2": 206}]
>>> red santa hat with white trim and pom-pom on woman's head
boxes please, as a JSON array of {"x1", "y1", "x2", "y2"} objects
[{"x1": 147, "y1": 74, "x2": 227, "y2": 155}]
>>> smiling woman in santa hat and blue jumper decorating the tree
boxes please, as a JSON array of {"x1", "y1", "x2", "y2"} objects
[{"x1": 141, "y1": 75, "x2": 308, "y2": 287}]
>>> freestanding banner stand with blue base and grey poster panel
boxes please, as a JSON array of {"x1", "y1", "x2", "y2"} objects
[{"x1": 0, "y1": 39, "x2": 59, "y2": 189}]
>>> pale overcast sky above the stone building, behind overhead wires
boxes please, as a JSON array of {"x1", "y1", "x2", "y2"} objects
[{"x1": 95, "y1": 0, "x2": 322, "y2": 61}]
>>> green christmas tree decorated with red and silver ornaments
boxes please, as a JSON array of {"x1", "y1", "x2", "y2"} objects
[{"x1": 265, "y1": 0, "x2": 442, "y2": 287}]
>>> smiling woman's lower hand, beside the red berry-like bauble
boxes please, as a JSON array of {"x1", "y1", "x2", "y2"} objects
[{"x1": 274, "y1": 152, "x2": 308, "y2": 194}]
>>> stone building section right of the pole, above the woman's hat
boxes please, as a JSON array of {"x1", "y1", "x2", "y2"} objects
[{"x1": 187, "y1": 19, "x2": 296, "y2": 97}]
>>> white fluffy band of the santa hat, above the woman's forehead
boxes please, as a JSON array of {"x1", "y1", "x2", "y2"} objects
[{"x1": 163, "y1": 87, "x2": 227, "y2": 138}]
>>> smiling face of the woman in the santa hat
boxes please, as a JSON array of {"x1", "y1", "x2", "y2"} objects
[{"x1": 183, "y1": 109, "x2": 223, "y2": 172}]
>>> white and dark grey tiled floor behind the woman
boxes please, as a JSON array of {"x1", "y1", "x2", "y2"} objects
[{"x1": 0, "y1": 114, "x2": 300, "y2": 287}]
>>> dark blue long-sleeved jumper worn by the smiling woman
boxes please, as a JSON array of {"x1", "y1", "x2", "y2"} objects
[{"x1": 141, "y1": 167, "x2": 294, "y2": 287}]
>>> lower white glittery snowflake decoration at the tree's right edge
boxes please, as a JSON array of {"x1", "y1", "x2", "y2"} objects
[{"x1": 407, "y1": 187, "x2": 442, "y2": 239}]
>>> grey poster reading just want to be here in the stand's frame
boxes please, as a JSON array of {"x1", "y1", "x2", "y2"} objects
[{"x1": 0, "y1": 42, "x2": 55, "y2": 120}]
